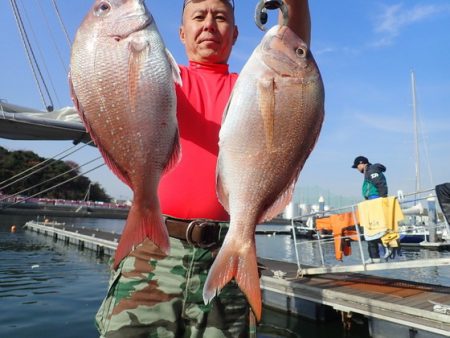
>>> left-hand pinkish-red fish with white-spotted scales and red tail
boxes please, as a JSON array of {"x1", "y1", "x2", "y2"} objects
[{"x1": 70, "y1": 0, "x2": 181, "y2": 267}]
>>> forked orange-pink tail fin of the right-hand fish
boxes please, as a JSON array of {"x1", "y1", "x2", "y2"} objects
[{"x1": 203, "y1": 236, "x2": 262, "y2": 321}]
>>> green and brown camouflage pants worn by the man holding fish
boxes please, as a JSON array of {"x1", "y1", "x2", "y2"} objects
[{"x1": 96, "y1": 227, "x2": 253, "y2": 338}]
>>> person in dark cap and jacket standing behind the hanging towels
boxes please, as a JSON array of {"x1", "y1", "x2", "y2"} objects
[{"x1": 352, "y1": 156, "x2": 388, "y2": 263}]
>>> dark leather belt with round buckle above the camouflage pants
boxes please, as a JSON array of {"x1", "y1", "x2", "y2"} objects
[{"x1": 165, "y1": 217, "x2": 225, "y2": 248}]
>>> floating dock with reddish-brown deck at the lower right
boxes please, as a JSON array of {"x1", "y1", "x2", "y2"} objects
[{"x1": 260, "y1": 259, "x2": 450, "y2": 337}]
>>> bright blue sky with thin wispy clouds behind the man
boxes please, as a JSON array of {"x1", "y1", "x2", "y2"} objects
[{"x1": 0, "y1": 0, "x2": 450, "y2": 203}]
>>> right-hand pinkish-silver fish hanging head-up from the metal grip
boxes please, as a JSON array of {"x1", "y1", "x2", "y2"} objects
[{"x1": 203, "y1": 26, "x2": 324, "y2": 320}]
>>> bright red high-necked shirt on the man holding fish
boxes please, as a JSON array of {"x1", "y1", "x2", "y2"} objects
[{"x1": 159, "y1": 62, "x2": 238, "y2": 221}]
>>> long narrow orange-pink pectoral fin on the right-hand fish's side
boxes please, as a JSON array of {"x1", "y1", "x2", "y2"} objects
[{"x1": 257, "y1": 78, "x2": 275, "y2": 150}]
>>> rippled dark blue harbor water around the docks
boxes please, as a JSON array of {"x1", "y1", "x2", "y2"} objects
[{"x1": 0, "y1": 215, "x2": 450, "y2": 338}]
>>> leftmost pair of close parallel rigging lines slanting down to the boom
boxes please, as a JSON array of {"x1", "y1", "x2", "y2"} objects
[{"x1": 10, "y1": 0, "x2": 53, "y2": 111}]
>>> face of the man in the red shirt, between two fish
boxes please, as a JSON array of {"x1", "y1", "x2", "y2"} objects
[{"x1": 180, "y1": 0, "x2": 238, "y2": 63}]
